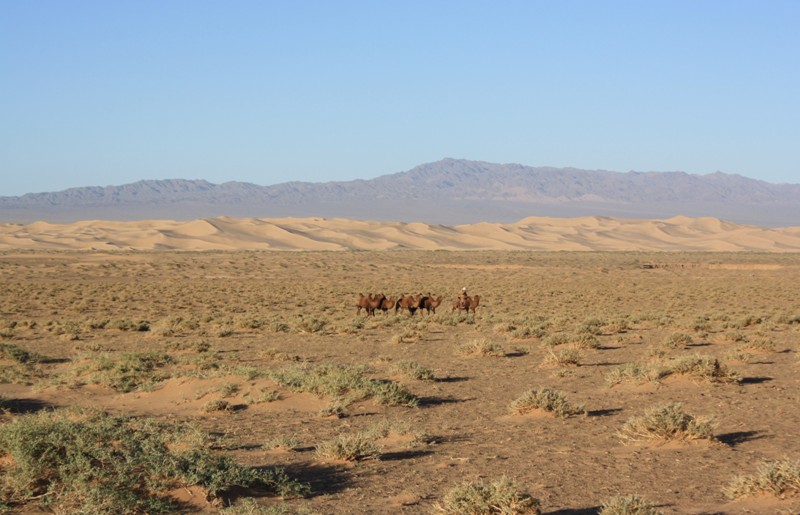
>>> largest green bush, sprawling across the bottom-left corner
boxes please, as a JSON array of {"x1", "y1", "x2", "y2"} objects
[{"x1": 0, "y1": 409, "x2": 308, "y2": 514}]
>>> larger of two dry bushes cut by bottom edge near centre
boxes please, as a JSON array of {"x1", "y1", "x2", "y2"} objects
[{"x1": 436, "y1": 476, "x2": 541, "y2": 515}]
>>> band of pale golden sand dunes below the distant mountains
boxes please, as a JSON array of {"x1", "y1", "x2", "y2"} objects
[{"x1": 0, "y1": 216, "x2": 800, "y2": 252}]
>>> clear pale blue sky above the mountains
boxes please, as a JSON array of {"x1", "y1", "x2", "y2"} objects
[{"x1": 0, "y1": 0, "x2": 800, "y2": 195}]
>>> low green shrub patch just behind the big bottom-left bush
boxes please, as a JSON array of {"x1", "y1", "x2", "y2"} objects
[{"x1": 65, "y1": 351, "x2": 175, "y2": 392}]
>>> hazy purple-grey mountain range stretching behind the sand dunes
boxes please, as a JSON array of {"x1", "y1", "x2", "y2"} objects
[{"x1": 0, "y1": 159, "x2": 800, "y2": 227}]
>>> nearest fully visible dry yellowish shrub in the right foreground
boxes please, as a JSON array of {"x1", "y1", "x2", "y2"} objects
[{"x1": 618, "y1": 403, "x2": 716, "y2": 442}]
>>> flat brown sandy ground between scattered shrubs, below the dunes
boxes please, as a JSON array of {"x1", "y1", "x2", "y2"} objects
[{"x1": 0, "y1": 248, "x2": 800, "y2": 514}]
